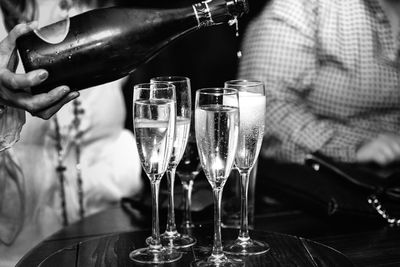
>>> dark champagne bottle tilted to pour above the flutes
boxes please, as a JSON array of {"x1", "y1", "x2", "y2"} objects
[{"x1": 17, "y1": 0, "x2": 248, "y2": 94}]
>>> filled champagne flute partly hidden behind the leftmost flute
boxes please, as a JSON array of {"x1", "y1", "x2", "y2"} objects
[{"x1": 150, "y1": 76, "x2": 196, "y2": 248}]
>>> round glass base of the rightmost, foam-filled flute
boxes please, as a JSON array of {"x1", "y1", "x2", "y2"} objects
[{"x1": 224, "y1": 238, "x2": 270, "y2": 256}]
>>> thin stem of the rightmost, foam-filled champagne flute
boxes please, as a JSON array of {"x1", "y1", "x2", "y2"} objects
[{"x1": 239, "y1": 170, "x2": 250, "y2": 241}]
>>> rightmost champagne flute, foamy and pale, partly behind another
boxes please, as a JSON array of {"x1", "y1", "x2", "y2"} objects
[{"x1": 224, "y1": 80, "x2": 269, "y2": 255}]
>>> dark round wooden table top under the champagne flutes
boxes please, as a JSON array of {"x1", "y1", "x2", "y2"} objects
[{"x1": 39, "y1": 225, "x2": 354, "y2": 267}]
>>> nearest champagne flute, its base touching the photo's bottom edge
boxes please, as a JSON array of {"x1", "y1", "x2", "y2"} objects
[{"x1": 192, "y1": 88, "x2": 242, "y2": 267}]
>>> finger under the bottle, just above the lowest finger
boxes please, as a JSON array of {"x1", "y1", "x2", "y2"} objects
[{"x1": 15, "y1": 86, "x2": 70, "y2": 114}]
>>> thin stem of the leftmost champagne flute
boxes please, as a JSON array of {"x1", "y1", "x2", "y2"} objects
[{"x1": 150, "y1": 179, "x2": 161, "y2": 249}]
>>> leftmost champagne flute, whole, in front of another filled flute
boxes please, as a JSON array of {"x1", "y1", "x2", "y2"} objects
[{"x1": 129, "y1": 83, "x2": 182, "y2": 264}]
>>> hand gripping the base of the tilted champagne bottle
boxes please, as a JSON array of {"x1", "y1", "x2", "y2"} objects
[{"x1": 0, "y1": 23, "x2": 79, "y2": 119}]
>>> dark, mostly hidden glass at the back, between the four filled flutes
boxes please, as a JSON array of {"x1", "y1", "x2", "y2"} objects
[{"x1": 176, "y1": 119, "x2": 201, "y2": 234}]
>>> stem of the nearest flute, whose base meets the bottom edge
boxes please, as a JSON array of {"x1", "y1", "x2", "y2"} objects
[{"x1": 211, "y1": 187, "x2": 224, "y2": 259}]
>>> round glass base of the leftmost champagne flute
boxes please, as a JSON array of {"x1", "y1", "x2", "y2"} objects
[{"x1": 129, "y1": 247, "x2": 182, "y2": 264}]
